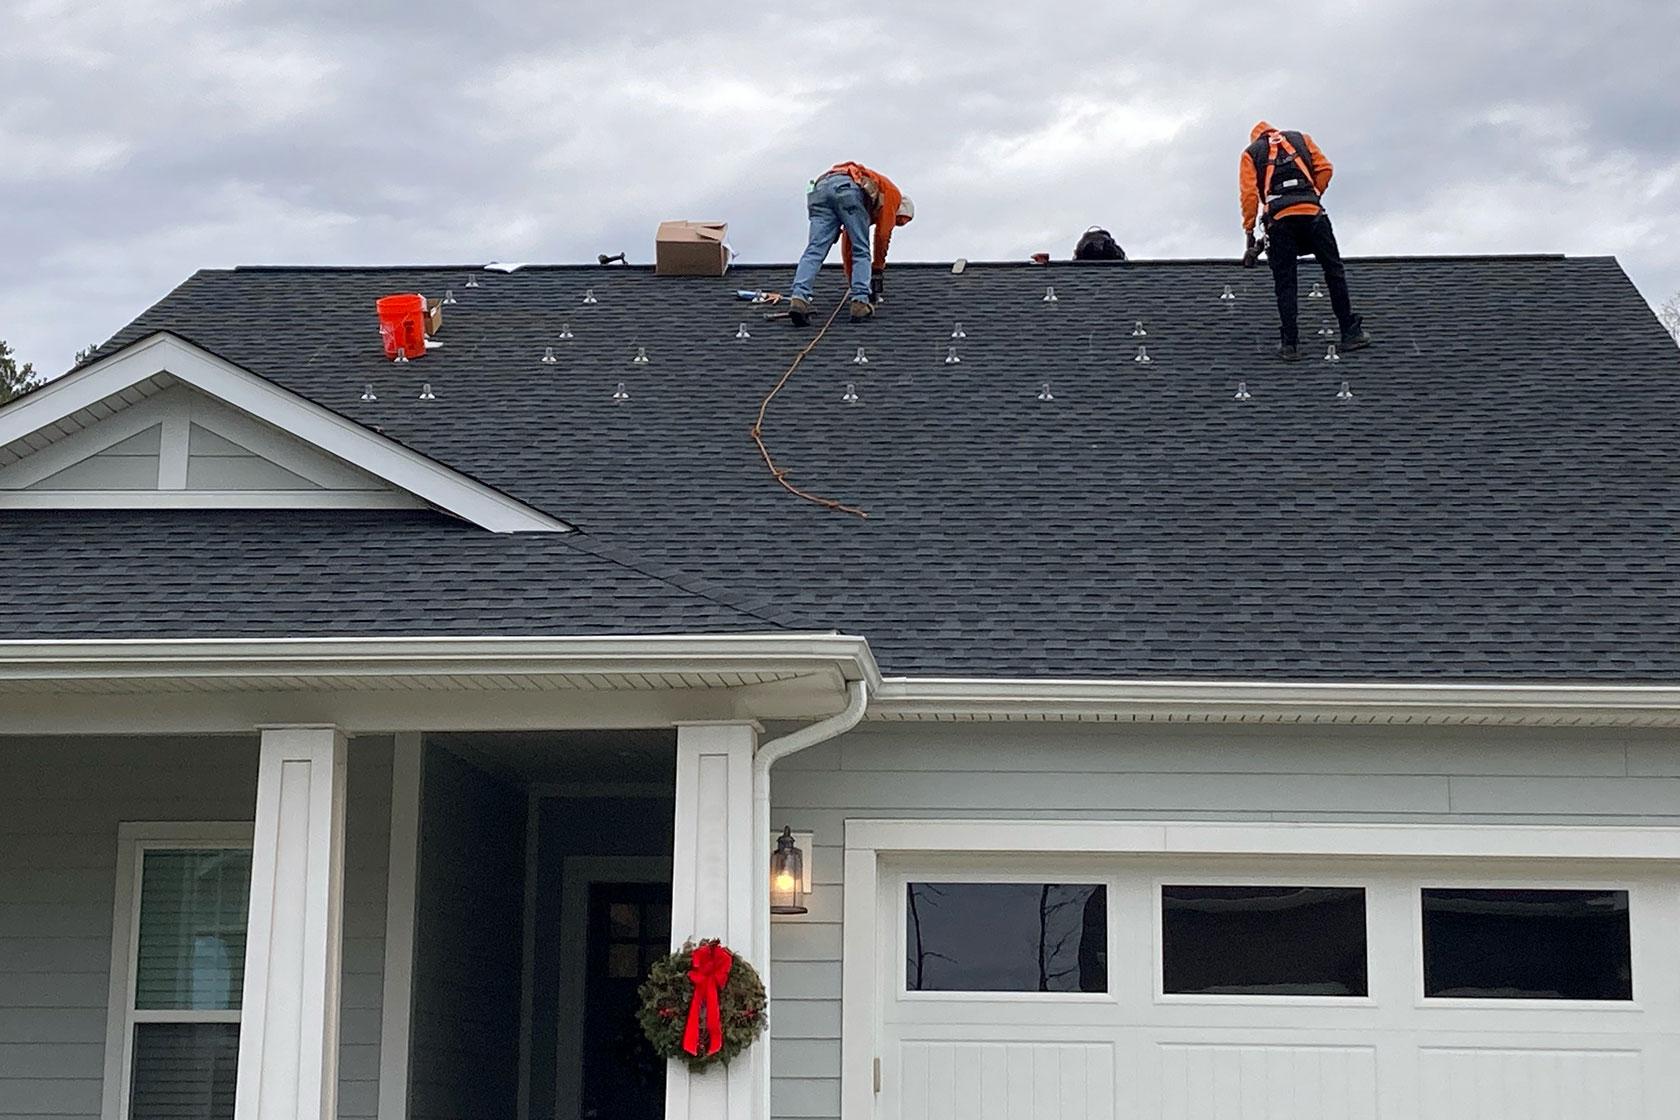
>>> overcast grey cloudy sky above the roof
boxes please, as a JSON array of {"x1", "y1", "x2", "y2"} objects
[{"x1": 0, "y1": 0, "x2": 1680, "y2": 373}]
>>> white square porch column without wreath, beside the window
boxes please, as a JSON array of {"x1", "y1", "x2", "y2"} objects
[{"x1": 234, "y1": 727, "x2": 344, "y2": 1120}]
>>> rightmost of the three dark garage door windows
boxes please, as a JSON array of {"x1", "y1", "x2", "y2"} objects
[{"x1": 1423, "y1": 887, "x2": 1633, "y2": 999}]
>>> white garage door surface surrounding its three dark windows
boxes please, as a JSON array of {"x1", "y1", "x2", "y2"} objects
[{"x1": 873, "y1": 856, "x2": 1680, "y2": 1120}]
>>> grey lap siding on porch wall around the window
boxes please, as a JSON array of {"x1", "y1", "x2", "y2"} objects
[{"x1": 0, "y1": 735, "x2": 391, "y2": 1120}]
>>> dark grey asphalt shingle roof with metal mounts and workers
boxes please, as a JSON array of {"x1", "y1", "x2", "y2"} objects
[{"x1": 0, "y1": 257, "x2": 1680, "y2": 680}]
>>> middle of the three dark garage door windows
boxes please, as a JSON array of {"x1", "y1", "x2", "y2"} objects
[{"x1": 1161, "y1": 887, "x2": 1368, "y2": 996}]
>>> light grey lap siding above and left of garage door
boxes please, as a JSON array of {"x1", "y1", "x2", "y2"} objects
[{"x1": 771, "y1": 724, "x2": 1680, "y2": 1120}]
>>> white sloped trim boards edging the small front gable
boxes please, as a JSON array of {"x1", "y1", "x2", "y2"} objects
[{"x1": 0, "y1": 332, "x2": 571, "y2": 532}]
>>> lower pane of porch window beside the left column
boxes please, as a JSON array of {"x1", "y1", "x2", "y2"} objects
[{"x1": 128, "y1": 1023, "x2": 239, "y2": 1120}]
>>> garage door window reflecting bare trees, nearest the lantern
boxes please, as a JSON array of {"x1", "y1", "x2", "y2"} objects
[{"x1": 906, "y1": 883, "x2": 1109, "y2": 992}]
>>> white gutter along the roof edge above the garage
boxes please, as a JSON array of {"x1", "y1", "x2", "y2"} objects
[{"x1": 870, "y1": 677, "x2": 1680, "y2": 725}]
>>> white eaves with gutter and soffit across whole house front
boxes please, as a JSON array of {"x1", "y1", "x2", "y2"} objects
[{"x1": 0, "y1": 633, "x2": 1680, "y2": 734}]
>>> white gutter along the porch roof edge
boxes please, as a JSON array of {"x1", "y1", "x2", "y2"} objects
[{"x1": 0, "y1": 635, "x2": 880, "y2": 687}]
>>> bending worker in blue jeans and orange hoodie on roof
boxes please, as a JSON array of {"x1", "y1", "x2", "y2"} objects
[{"x1": 788, "y1": 163, "x2": 916, "y2": 327}]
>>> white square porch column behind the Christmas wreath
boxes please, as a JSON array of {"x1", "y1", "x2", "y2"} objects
[{"x1": 665, "y1": 722, "x2": 769, "y2": 1120}]
